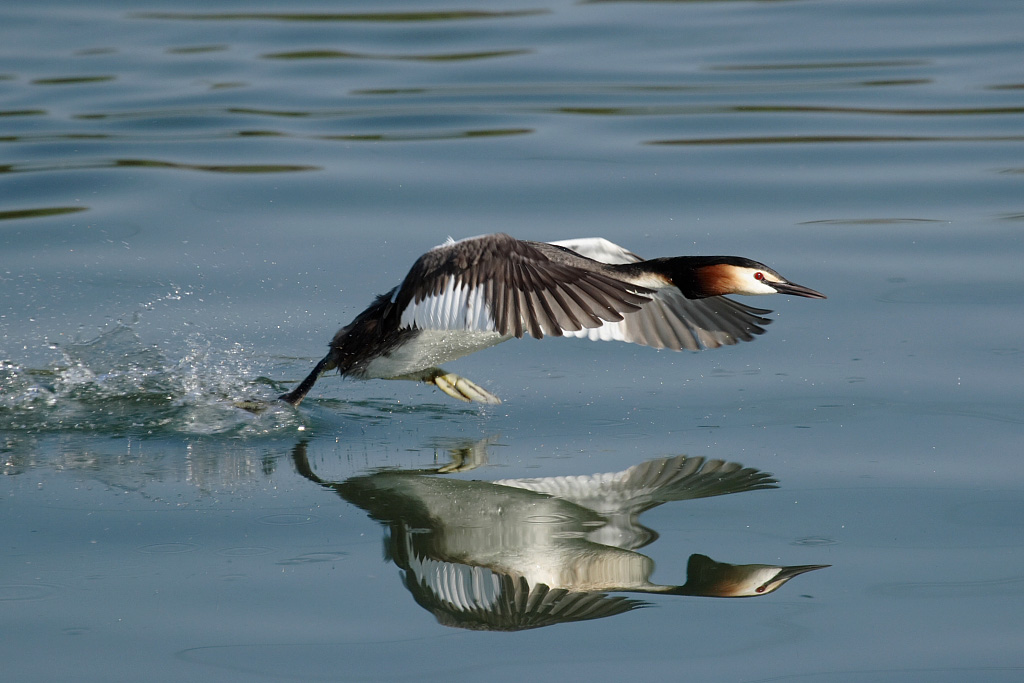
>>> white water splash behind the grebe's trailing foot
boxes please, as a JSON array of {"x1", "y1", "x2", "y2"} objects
[{"x1": 0, "y1": 321, "x2": 300, "y2": 435}]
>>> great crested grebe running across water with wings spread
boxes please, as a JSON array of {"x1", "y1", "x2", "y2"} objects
[{"x1": 280, "y1": 232, "x2": 825, "y2": 405}]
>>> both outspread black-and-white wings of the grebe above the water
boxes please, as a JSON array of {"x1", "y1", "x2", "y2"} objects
[{"x1": 393, "y1": 234, "x2": 770, "y2": 350}]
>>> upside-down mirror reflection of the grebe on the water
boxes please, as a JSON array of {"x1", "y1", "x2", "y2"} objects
[{"x1": 293, "y1": 440, "x2": 828, "y2": 631}]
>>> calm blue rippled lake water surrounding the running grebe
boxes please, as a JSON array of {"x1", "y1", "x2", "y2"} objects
[{"x1": 0, "y1": 0, "x2": 1024, "y2": 682}]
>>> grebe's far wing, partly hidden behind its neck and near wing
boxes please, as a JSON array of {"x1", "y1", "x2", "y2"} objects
[{"x1": 551, "y1": 238, "x2": 771, "y2": 351}]
